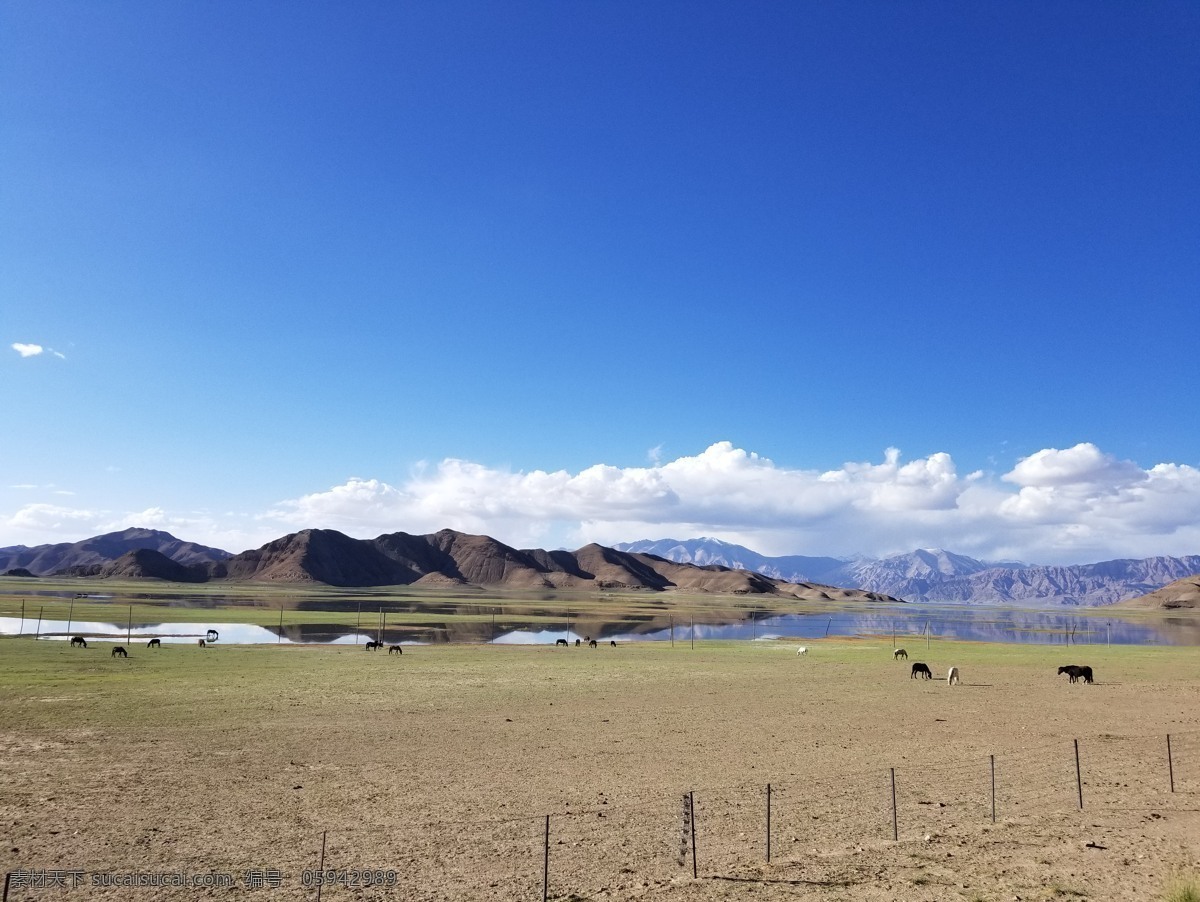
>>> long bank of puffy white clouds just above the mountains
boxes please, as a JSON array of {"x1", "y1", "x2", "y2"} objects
[{"x1": 7, "y1": 441, "x2": 1200, "y2": 564}]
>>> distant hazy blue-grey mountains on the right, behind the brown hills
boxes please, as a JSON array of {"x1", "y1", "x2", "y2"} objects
[{"x1": 614, "y1": 537, "x2": 1200, "y2": 606}]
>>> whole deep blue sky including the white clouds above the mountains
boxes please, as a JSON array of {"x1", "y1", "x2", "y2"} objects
[{"x1": 0, "y1": 0, "x2": 1200, "y2": 563}]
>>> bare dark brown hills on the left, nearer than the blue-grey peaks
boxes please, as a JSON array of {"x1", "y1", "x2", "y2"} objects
[{"x1": 0, "y1": 529, "x2": 899, "y2": 601}]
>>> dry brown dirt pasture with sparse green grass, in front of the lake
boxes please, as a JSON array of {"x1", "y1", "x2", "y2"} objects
[{"x1": 0, "y1": 639, "x2": 1200, "y2": 902}]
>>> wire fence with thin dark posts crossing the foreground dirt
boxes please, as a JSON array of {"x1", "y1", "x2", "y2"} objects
[{"x1": 5, "y1": 733, "x2": 1200, "y2": 902}]
